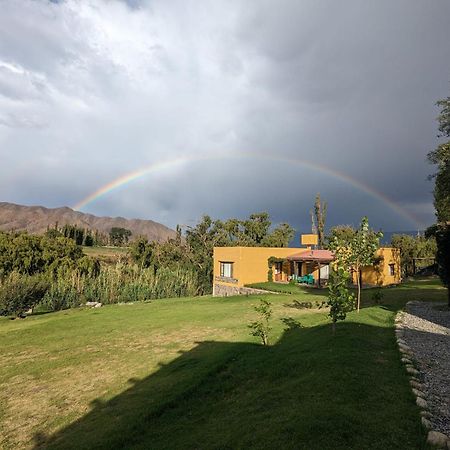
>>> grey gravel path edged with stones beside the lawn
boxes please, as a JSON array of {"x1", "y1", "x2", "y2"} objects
[{"x1": 402, "y1": 302, "x2": 450, "y2": 436}]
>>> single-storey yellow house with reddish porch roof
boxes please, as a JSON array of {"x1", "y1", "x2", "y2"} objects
[{"x1": 213, "y1": 235, "x2": 401, "y2": 296}]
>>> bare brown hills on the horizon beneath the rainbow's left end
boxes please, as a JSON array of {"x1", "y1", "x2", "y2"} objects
[{"x1": 0, "y1": 202, "x2": 175, "y2": 242}]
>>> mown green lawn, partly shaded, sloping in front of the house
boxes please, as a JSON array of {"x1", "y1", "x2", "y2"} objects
[{"x1": 0, "y1": 281, "x2": 446, "y2": 450}]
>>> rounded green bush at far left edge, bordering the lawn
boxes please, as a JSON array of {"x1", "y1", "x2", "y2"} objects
[{"x1": 0, "y1": 272, "x2": 49, "y2": 317}]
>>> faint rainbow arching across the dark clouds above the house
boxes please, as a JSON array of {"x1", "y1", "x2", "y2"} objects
[{"x1": 73, "y1": 152, "x2": 425, "y2": 229}]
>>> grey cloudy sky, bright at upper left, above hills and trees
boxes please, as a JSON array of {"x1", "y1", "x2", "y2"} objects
[{"x1": 0, "y1": 0, "x2": 450, "y2": 231}]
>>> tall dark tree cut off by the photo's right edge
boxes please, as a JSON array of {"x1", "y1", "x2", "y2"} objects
[{"x1": 428, "y1": 97, "x2": 450, "y2": 307}]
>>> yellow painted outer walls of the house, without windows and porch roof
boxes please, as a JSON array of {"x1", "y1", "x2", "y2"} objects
[{"x1": 213, "y1": 247, "x2": 401, "y2": 287}]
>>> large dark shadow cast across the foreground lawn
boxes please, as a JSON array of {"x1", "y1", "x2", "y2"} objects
[{"x1": 35, "y1": 323, "x2": 424, "y2": 450}]
